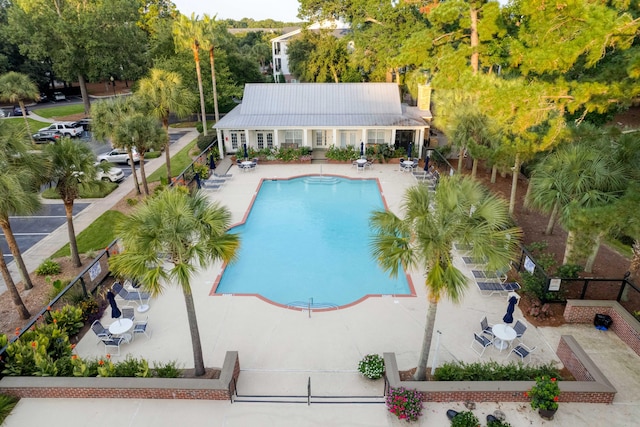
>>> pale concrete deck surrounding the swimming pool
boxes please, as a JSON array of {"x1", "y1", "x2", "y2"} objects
[{"x1": 5, "y1": 164, "x2": 640, "y2": 427}]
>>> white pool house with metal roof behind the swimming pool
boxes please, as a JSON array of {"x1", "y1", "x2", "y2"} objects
[{"x1": 214, "y1": 83, "x2": 431, "y2": 159}]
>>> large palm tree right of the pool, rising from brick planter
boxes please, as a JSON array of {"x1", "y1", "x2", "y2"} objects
[{"x1": 370, "y1": 175, "x2": 521, "y2": 380}]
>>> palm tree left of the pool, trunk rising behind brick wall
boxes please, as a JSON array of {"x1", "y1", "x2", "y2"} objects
[{"x1": 109, "y1": 188, "x2": 240, "y2": 376}]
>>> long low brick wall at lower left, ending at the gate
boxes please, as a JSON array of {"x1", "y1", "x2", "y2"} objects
[{"x1": 0, "y1": 351, "x2": 240, "y2": 400}]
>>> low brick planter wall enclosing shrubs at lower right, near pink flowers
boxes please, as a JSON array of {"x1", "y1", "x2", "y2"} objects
[{"x1": 384, "y1": 335, "x2": 616, "y2": 403}]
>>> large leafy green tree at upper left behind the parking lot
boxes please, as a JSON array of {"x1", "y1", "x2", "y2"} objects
[{"x1": 8, "y1": 0, "x2": 146, "y2": 114}]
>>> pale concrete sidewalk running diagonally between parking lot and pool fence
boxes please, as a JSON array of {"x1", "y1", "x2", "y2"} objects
[{"x1": 0, "y1": 127, "x2": 198, "y2": 294}]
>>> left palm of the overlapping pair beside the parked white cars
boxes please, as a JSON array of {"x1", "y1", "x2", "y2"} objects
[{"x1": 91, "y1": 97, "x2": 142, "y2": 194}]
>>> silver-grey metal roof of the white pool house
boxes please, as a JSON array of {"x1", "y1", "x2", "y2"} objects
[{"x1": 214, "y1": 83, "x2": 426, "y2": 129}]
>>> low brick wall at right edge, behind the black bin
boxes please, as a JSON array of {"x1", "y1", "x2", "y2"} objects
[{"x1": 564, "y1": 300, "x2": 640, "y2": 356}]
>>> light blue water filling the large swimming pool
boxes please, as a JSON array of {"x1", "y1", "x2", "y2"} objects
[{"x1": 216, "y1": 177, "x2": 410, "y2": 306}]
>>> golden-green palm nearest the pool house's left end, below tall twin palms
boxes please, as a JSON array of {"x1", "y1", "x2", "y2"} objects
[{"x1": 138, "y1": 68, "x2": 195, "y2": 182}]
